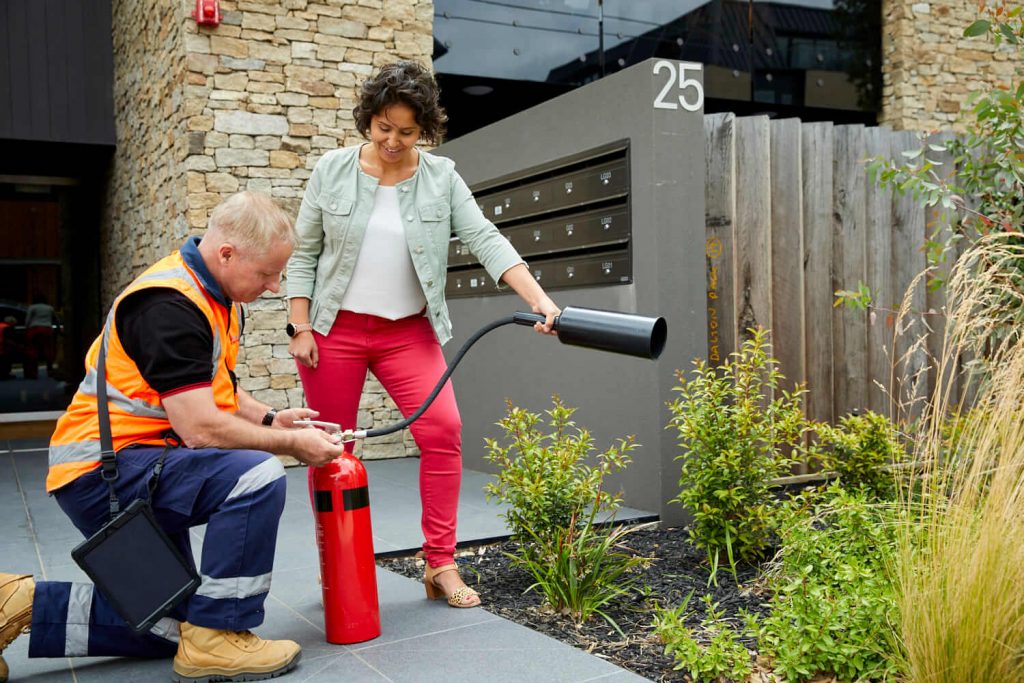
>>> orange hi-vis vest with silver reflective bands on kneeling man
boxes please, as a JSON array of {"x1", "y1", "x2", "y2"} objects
[{"x1": 46, "y1": 252, "x2": 239, "y2": 493}]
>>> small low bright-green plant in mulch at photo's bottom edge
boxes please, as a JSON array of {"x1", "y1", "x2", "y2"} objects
[{"x1": 654, "y1": 591, "x2": 754, "y2": 683}]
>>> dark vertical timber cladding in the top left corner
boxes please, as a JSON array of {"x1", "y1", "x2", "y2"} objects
[{"x1": 0, "y1": 0, "x2": 115, "y2": 144}]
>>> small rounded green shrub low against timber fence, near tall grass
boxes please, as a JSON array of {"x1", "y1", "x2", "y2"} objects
[{"x1": 816, "y1": 411, "x2": 906, "y2": 501}]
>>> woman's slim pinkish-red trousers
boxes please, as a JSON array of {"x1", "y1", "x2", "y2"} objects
[{"x1": 297, "y1": 310, "x2": 462, "y2": 567}]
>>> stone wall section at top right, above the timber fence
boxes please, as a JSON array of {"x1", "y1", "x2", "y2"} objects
[{"x1": 879, "y1": 0, "x2": 1021, "y2": 131}]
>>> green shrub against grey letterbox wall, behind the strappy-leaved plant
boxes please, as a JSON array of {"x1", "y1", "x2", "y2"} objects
[{"x1": 484, "y1": 395, "x2": 636, "y2": 546}]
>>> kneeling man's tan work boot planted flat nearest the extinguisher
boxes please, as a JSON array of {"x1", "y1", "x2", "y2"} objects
[{"x1": 174, "y1": 622, "x2": 302, "y2": 683}]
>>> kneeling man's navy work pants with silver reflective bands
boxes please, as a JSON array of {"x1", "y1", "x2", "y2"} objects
[{"x1": 29, "y1": 446, "x2": 285, "y2": 657}]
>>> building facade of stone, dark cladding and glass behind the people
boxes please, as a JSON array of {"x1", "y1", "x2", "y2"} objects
[{"x1": 0, "y1": 0, "x2": 1020, "y2": 450}]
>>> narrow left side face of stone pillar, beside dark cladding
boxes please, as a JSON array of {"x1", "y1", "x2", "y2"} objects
[{"x1": 100, "y1": 0, "x2": 188, "y2": 309}]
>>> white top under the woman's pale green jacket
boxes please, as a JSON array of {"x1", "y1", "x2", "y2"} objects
[{"x1": 341, "y1": 185, "x2": 427, "y2": 321}]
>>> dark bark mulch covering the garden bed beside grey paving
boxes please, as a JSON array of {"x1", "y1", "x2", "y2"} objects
[{"x1": 378, "y1": 525, "x2": 770, "y2": 681}]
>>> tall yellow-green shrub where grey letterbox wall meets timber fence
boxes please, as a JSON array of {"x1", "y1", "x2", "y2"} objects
[{"x1": 669, "y1": 330, "x2": 810, "y2": 561}]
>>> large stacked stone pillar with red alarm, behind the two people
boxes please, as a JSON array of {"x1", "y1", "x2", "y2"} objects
[{"x1": 104, "y1": 0, "x2": 433, "y2": 458}]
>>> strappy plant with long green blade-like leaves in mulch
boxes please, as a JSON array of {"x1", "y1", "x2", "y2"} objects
[{"x1": 510, "y1": 503, "x2": 649, "y2": 637}]
